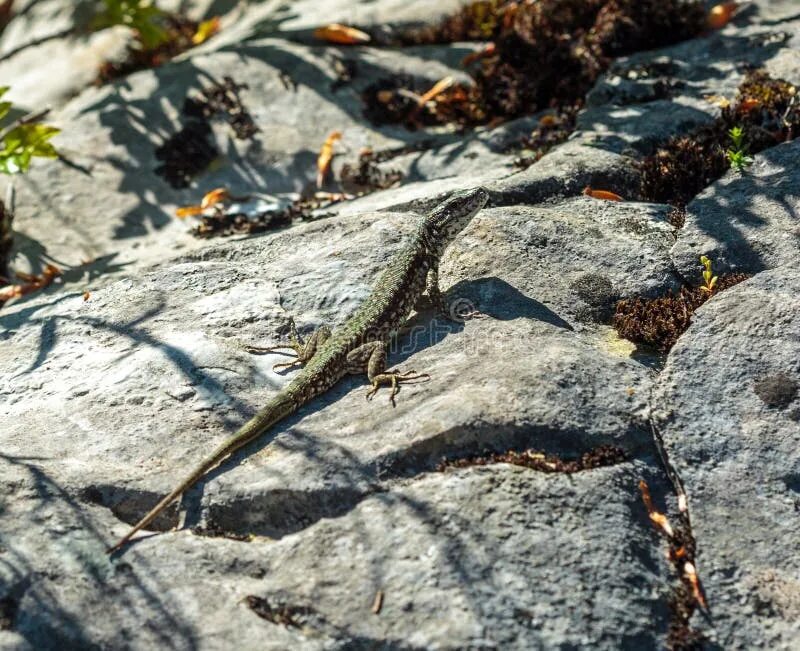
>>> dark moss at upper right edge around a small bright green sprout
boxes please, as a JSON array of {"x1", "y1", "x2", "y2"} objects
[{"x1": 640, "y1": 70, "x2": 800, "y2": 207}]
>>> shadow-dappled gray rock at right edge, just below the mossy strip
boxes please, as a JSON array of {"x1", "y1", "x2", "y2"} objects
[{"x1": 672, "y1": 141, "x2": 800, "y2": 284}]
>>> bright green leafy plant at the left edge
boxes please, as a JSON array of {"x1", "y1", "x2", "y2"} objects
[{"x1": 0, "y1": 86, "x2": 60, "y2": 174}]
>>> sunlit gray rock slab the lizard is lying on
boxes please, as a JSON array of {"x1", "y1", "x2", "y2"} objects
[{"x1": 0, "y1": 197, "x2": 675, "y2": 535}]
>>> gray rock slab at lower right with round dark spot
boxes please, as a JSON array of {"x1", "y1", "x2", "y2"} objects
[{"x1": 654, "y1": 266, "x2": 800, "y2": 649}]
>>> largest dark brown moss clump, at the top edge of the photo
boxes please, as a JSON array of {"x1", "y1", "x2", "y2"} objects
[{"x1": 378, "y1": 0, "x2": 705, "y2": 125}]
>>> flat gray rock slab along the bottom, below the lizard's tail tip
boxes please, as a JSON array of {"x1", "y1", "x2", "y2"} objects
[{"x1": 0, "y1": 456, "x2": 668, "y2": 650}]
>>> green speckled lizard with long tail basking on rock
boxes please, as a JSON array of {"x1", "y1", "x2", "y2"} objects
[{"x1": 107, "y1": 187, "x2": 489, "y2": 554}]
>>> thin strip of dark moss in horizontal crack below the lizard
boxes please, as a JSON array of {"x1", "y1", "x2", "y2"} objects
[{"x1": 436, "y1": 445, "x2": 627, "y2": 474}]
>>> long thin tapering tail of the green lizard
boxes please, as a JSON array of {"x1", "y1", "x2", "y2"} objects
[{"x1": 106, "y1": 396, "x2": 297, "y2": 554}]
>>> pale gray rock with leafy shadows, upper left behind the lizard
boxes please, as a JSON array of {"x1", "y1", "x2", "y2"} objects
[{"x1": 6, "y1": 40, "x2": 476, "y2": 278}]
